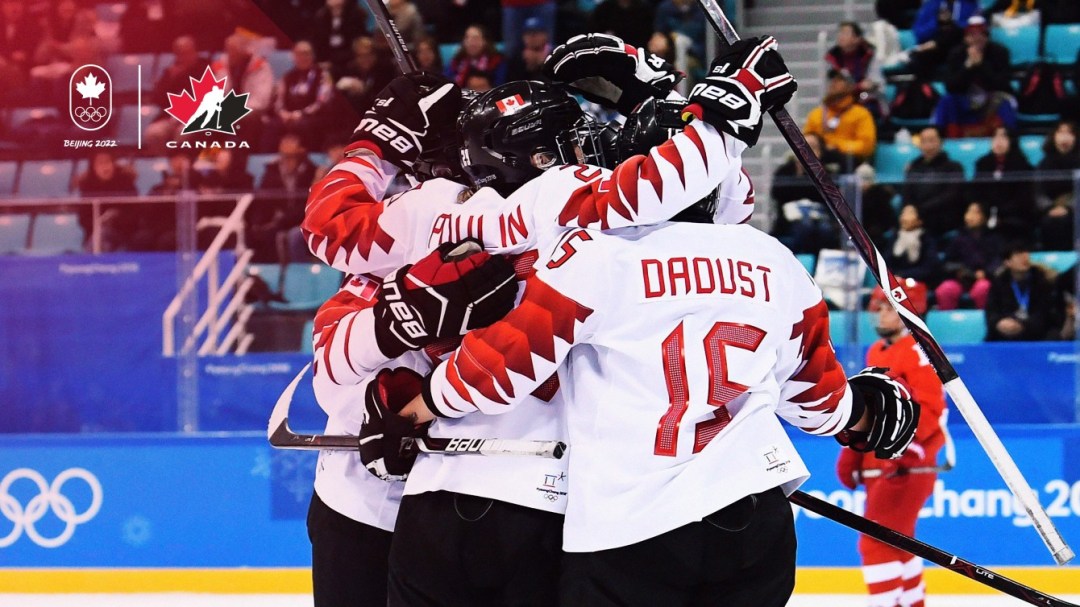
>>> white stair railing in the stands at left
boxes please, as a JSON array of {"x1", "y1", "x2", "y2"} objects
[{"x1": 161, "y1": 194, "x2": 255, "y2": 356}]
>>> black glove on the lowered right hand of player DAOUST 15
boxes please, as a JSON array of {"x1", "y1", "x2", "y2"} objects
[{"x1": 836, "y1": 367, "x2": 920, "y2": 459}]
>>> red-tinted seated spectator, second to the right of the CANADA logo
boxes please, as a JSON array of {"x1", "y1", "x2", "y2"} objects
[{"x1": 267, "y1": 40, "x2": 334, "y2": 147}]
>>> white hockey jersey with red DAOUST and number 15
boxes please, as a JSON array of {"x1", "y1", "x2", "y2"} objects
[{"x1": 429, "y1": 224, "x2": 851, "y2": 552}]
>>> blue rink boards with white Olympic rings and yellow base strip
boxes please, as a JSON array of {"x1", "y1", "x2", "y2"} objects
[{"x1": 0, "y1": 426, "x2": 1080, "y2": 593}]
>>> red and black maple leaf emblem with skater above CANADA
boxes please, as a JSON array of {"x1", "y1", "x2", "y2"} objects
[{"x1": 165, "y1": 67, "x2": 252, "y2": 135}]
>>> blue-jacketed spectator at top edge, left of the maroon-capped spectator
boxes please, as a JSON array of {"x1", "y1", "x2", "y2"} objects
[{"x1": 908, "y1": 0, "x2": 978, "y2": 80}]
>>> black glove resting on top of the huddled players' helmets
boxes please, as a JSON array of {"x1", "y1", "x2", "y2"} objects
[{"x1": 543, "y1": 33, "x2": 684, "y2": 116}]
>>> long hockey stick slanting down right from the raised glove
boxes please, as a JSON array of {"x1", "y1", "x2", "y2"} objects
[{"x1": 698, "y1": 0, "x2": 1074, "y2": 565}]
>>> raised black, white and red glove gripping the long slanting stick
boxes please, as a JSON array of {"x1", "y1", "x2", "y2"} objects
[{"x1": 683, "y1": 36, "x2": 798, "y2": 146}]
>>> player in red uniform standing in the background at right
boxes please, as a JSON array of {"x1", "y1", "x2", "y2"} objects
[{"x1": 837, "y1": 280, "x2": 946, "y2": 607}]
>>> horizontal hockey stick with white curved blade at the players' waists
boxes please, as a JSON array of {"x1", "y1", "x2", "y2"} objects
[{"x1": 267, "y1": 363, "x2": 566, "y2": 459}]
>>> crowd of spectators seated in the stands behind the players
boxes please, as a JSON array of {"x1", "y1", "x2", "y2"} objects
[{"x1": 0, "y1": 0, "x2": 1080, "y2": 339}]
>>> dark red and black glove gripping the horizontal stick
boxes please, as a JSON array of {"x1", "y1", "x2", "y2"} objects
[{"x1": 360, "y1": 367, "x2": 429, "y2": 481}]
